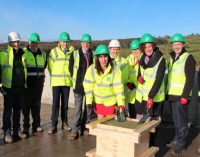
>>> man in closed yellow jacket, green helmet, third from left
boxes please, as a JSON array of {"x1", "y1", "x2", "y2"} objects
[{"x1": 48, "y1": 32, "x2": 74, "y2": 134}]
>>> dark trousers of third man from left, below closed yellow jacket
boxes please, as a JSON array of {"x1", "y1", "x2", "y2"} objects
[{"x1": 51, "y1": 86, "x2": 70, "y2": 127}]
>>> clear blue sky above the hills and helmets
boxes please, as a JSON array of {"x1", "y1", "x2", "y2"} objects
[{"x1": 0, "y1": 0, "x2": 200, "y2": 42}]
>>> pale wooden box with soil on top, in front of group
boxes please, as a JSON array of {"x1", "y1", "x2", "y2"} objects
[{"x1": 86, "y1": 116, "x2": 160, "y2": 157}]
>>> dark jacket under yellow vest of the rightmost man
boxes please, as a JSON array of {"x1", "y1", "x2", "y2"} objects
[{"x1": 167, "y1": 48, "x2": 196, "y2": 101}]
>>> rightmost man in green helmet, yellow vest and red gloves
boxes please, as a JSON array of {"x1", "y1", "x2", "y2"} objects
[{"x1": 167, "y1": 33, "x2": 196, "y2": 155}]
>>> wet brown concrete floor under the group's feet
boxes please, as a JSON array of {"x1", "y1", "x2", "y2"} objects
[{"x1": 0, "y1": 98, "x2": 200, "y2": 157}]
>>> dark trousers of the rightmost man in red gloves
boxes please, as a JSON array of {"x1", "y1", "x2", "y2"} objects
[{"x1": 170, "y1": 101, "x2": 189, "y2": 150}]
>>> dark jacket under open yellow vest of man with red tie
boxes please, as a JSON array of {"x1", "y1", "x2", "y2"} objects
[{"x1": 69, "y1": 48, "x2": 93, "y2": 95}]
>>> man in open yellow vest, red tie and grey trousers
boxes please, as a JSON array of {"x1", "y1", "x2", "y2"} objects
[{"x1": 68, "y1": 34, "x2": 93, "y2": 140}]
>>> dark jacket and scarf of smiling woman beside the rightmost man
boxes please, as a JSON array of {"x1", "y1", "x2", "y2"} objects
[{"x1": 138, "y1": 47, "x2": 166, "y2": 98}]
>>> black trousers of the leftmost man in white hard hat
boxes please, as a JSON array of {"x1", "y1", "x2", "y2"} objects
[{"x1": 3, "y1": 87, "x2": 24, "y2": 135}]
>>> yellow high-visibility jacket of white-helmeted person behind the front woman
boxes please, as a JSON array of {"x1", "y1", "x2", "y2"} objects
[{"x1": 114, "y1": 56, "x2": 129, "y2": 85}]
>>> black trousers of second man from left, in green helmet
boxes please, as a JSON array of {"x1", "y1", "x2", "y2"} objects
[{"x1": 22, "y1": 88, "x2": 43, "y2": 131}]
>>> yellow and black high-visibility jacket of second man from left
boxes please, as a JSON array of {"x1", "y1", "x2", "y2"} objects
[{"x1": 23, "y1": 48, "x2": 46, "y2": 86}]
